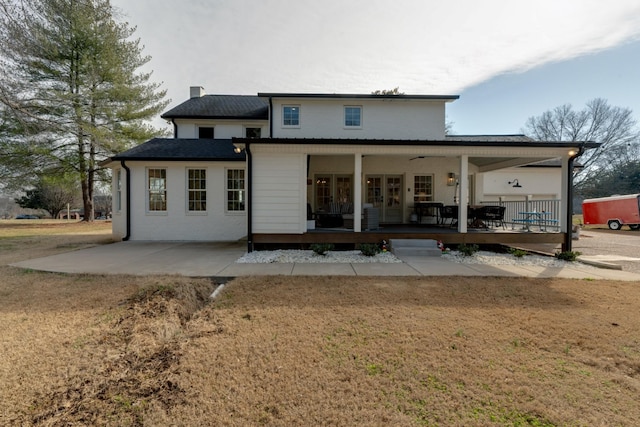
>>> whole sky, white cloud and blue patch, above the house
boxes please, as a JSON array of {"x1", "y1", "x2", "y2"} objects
[{"x1": 112, "y1": 0, "x2": 640, "y2": 134}]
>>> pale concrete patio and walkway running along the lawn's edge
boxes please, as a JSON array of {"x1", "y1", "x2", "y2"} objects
[{"x1": 11, "y1": 242, "x2": 640, "y2": 282}]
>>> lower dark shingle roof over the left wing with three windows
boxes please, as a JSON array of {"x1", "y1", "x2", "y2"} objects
[{"x1": 111, "y1": 138, "x2": 245, "y2": 161}]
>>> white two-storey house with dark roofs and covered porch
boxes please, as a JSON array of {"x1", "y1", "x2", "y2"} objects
[{"x1": 103, "y1": 87, "x2": 597, "y2": 250}]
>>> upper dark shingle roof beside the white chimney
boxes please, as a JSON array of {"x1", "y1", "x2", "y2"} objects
[{"x1": 161, "y1": 95, "x2": 269, "y2": 120}]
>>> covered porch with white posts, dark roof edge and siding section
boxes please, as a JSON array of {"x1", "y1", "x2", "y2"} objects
[{"x1": 234, "y1": 137, "x2": 592, "y2": 250}]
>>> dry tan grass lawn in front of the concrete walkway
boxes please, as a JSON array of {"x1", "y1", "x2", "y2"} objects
[{"x1": 0, "y1": 222, "x2": 640, "y2": 426}]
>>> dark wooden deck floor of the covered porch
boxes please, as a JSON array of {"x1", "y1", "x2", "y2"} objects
[{"x1": 253, "y1": 225, "x2": 566, "y2": 245}]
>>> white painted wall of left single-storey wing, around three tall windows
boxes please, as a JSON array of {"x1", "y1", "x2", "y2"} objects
[{"x1": 114, "y1": 162, "x2": 247, "y2": 241}]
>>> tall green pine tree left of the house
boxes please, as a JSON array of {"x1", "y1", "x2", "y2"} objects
[{"x1": 0, "y1": 0, "x2": 168, "y2": 220}]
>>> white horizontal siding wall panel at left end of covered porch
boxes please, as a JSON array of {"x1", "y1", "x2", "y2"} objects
[{"x1": 252, "y1": 153, "x2": 306, "y2": 233}]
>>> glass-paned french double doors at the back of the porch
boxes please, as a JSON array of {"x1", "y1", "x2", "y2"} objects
[{"x1": 366, "y1": 175, "x2": 404, "y2": 224}]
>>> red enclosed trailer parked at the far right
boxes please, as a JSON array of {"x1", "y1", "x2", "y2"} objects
[{"x1": 582, "y1": 194, "x2": 640, "y2": 230}]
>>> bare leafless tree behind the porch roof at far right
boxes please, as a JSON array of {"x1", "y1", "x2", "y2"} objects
[{"x1": 524, "y1": 98, "x2": 640, "y2": 182}]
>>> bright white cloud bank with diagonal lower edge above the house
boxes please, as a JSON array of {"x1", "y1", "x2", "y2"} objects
[{"x1": 113, "y1": 0, "x2": 640, "y2": 105}]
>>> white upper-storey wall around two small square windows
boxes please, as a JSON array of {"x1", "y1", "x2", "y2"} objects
[{"x1": 273, "y1": 98, "x2": 445, "y2": 140}]
